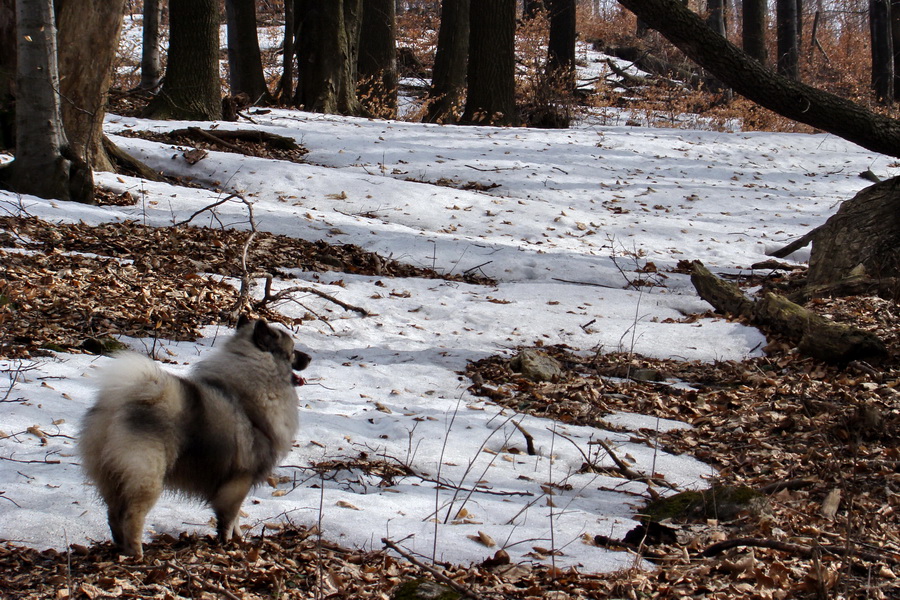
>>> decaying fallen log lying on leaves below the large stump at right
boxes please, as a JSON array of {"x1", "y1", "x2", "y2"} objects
[{"x1": 691, "y1": 260, "x2": 887, "y2": 364}]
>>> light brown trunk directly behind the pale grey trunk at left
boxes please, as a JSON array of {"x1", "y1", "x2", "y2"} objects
[{"x1": 56, "y1": 0, "x2": 125, "y2": 171}]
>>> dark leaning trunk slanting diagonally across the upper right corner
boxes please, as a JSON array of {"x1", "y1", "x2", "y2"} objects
[{"x1": 620, "y1": 0, "x2": 900, "y2": 157}]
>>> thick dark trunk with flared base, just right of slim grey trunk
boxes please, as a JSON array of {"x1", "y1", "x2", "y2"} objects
[{"x1": 146, "y1": 0, "x2": 222, "y2": 121}]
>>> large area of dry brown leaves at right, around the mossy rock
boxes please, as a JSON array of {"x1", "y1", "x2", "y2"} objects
[{"x1": 469, "y1": 298, "x2": 900, "y2": 599}]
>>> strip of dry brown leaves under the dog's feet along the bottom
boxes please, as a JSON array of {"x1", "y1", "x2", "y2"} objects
[{"x1": 0, "y1": 525, "x2": 648, "y2": 600}]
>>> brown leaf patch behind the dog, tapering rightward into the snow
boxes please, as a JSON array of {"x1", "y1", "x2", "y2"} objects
[{"x1": 0, "y1": 217, "x2": 486, "y2": 358}]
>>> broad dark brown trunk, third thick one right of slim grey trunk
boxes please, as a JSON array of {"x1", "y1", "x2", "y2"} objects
[{"x1": 294, "y1": 0, "x2": 364, "y2": 115}]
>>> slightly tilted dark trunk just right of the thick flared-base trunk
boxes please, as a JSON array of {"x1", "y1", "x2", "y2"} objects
[{"x1": 225, "y1": 0, "x2": 271, "y2": 104}]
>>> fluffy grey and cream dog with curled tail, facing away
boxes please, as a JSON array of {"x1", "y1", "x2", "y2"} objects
[{"x1": 79, "y1": 318, "x2": 310, "y2": 557}]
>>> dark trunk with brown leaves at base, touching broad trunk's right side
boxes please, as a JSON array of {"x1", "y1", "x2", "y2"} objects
[{"x1": 357, "y1": 0, "x2": 399, "y2": 119}]
